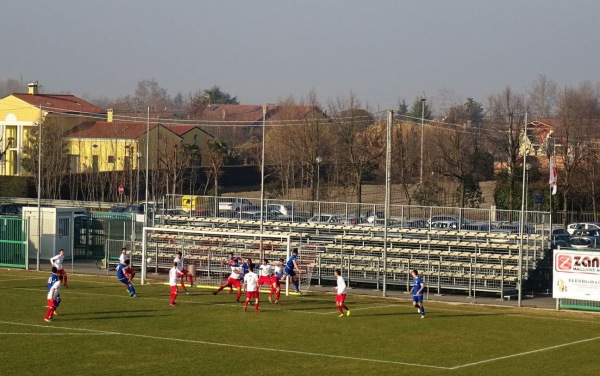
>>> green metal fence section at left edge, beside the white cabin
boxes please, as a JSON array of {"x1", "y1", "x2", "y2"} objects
[{"x1": 0, "y1": 218, "x2": 28, "y2": 269}]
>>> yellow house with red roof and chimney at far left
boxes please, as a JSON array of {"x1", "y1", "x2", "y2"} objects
[{"x1": 0, "y1": 83, "x2": 105, "y2": 175}]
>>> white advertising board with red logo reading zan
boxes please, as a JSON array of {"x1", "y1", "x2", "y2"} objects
[{"x1": 552, "y1": 249, "x2": 600, "y2": 301}]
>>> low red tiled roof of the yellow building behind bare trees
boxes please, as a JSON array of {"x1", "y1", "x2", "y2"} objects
[{"x1": 67, "y1": 121, "x2": 158, "y2": 140}]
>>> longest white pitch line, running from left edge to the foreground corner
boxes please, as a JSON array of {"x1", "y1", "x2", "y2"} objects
[{"x1": 0, "y1": 321, "x2": 450, "y2": 370}]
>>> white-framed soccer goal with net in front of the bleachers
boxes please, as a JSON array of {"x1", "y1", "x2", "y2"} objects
[{"x1": 140, "y1": 227, "x2": 316, "y2": 295}]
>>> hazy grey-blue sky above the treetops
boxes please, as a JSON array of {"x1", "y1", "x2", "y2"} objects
[{"x1": 0, "y1": 0, "x2": 600, "y2": 110}]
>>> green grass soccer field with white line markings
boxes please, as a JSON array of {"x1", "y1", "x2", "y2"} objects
[{"x1": 0, "y1": 269, "x2": 600, "y2": 376}]
